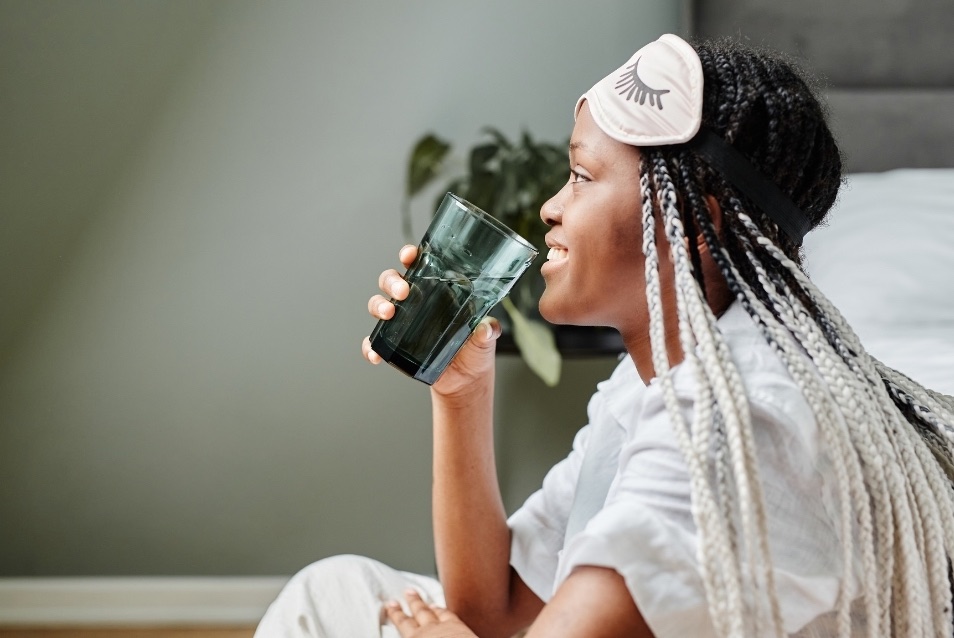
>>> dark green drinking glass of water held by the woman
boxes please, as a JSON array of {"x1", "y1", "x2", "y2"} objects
[{"x1": 371, "y1": 193, "x2": 537, "y2": 385}]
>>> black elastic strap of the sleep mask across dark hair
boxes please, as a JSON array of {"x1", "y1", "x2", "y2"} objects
[{"x1": 686, "y1": 128, "x2": 811, "y2": 244}]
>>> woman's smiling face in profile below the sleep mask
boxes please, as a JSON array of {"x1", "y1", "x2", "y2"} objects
[{"x1": 540, "y1": 103, "x2": 665, "y2": 336}]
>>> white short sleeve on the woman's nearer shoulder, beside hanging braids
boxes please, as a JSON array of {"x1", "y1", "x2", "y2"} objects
[{"x1": 556, "y1": 382, "x2": 715, "y2": 638}]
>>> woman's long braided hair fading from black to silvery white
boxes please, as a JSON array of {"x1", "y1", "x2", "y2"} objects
[{"x1": 640, "y1": 41, "x2": 954, "y2": 636}]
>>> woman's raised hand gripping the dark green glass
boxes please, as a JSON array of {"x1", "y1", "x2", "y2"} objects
[{"x1": 361, "y1": 245, "x2": 500, "y2": 397}]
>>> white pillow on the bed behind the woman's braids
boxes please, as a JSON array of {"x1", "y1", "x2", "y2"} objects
[{"x1": 805, "y1": 169, "x2": 954, "y2": 394}]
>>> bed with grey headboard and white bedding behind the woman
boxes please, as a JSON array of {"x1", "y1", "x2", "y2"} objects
[{"x1": 690, "y1": 0, "x2": 954, "y2": 394}]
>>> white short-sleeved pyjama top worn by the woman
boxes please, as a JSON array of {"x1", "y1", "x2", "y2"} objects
[{"x1": 509, "y1": 303, "x2": 857, "y2": 638}]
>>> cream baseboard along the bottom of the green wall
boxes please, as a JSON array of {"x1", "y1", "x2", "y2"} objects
[{"x1": 0, "y1": 577, "x2": 288, "y2": 626}]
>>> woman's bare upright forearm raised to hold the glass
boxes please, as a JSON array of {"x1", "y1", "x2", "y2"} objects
[{"x1": 431, "y1": 336, "x2": 543, "y2": 638}]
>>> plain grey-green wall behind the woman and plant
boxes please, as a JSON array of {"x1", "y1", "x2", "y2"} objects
[{"x1": 0, "y1": 0, "x2": 687, "y2": 577}]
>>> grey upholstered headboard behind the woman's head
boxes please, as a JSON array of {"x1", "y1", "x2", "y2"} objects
[{"x1": 691, "y1": 0, "x2": 954, "y2": 172}]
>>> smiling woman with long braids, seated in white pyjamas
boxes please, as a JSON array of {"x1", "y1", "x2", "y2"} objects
[{"x1": 260, "y1": 35, "x2": 954, "y2": 638}]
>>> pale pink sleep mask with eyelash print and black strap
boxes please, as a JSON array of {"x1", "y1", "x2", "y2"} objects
[{"x1": 573, "y1": 33, "x2": 811, "y2": 244}]
